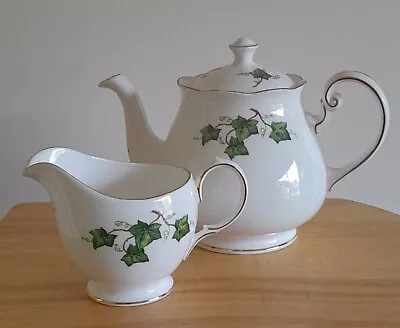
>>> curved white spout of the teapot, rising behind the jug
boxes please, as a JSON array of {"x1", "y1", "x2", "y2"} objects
[{"x1": 99, "y1": 74, "x2": 163, "y2": 162}]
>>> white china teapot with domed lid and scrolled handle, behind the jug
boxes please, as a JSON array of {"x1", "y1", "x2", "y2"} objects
[{"x1": 99, "y1": 38, "x2": 389, "y2": 254}]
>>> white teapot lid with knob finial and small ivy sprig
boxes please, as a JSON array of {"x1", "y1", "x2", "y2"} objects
[{"x1": 178, "y1": 37, "x2": 305, "y2": 94}]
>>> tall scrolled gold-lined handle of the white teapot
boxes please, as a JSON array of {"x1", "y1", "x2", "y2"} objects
[{"x1": 314, "y1": 71, "x2": 390, "y2": 191}]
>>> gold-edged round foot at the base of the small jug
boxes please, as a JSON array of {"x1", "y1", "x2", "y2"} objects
[{"x1": 87, "y1": 276, "x2": 174, "y2": 306}]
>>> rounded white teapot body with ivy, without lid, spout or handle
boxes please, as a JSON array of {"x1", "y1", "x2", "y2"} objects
[{"x1": 162, "y1": 85, "x2": 327, "y2": 253}]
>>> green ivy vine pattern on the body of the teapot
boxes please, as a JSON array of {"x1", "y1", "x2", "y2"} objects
[{"x1": 194, "y1": 108, "x2": 296, "y2": 159}]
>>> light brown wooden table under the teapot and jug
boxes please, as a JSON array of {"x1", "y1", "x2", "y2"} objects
[{"x1": 0, "y1": 200, "x2": 400, "y2": 328}]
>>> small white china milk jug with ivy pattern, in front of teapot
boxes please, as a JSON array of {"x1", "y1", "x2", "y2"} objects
[{"x1": 23, "y1": 147, "x2": 247, "y2": 306}]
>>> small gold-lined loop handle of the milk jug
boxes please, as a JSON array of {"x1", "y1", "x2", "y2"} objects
[{"x1": 183, "y1": 158, "x2": 249, "y2": 260}]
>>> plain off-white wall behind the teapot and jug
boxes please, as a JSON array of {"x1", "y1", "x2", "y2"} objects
[{"x1": 0, "y1": 0, "x2": 400, "y2": 219}]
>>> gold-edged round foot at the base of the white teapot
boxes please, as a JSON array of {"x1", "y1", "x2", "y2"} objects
[{"x1": 198, "y1": 229, "x2": 297, "y2": 255}]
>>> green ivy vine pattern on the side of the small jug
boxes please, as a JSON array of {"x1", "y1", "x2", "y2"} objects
[{"x1": 82, "y1": 210, "x2": 194, "y2": 267}]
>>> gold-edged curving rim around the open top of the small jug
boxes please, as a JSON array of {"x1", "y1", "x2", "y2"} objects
[{"x1": 23, "y1": 146, "x2": 194, "y2": 201}]
